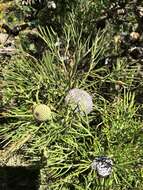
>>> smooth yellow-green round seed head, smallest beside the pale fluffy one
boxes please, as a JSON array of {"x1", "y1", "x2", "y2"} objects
[{"x1": 33, "y1": 104, "x2": 52, "y2": 121}]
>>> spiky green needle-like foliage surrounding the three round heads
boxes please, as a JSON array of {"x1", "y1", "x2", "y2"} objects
[{"x1": 0, "y1": 1, "x2": 143, "y2": 190}]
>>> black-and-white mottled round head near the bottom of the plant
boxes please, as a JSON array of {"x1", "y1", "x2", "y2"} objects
[{"x1": 91, "y1": 156, "x2": 113, "y2": 178}]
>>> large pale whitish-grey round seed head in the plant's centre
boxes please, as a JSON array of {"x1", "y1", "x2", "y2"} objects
[{"x1": 65, "y1": 88, "x2": 93, "y2": 115}]
